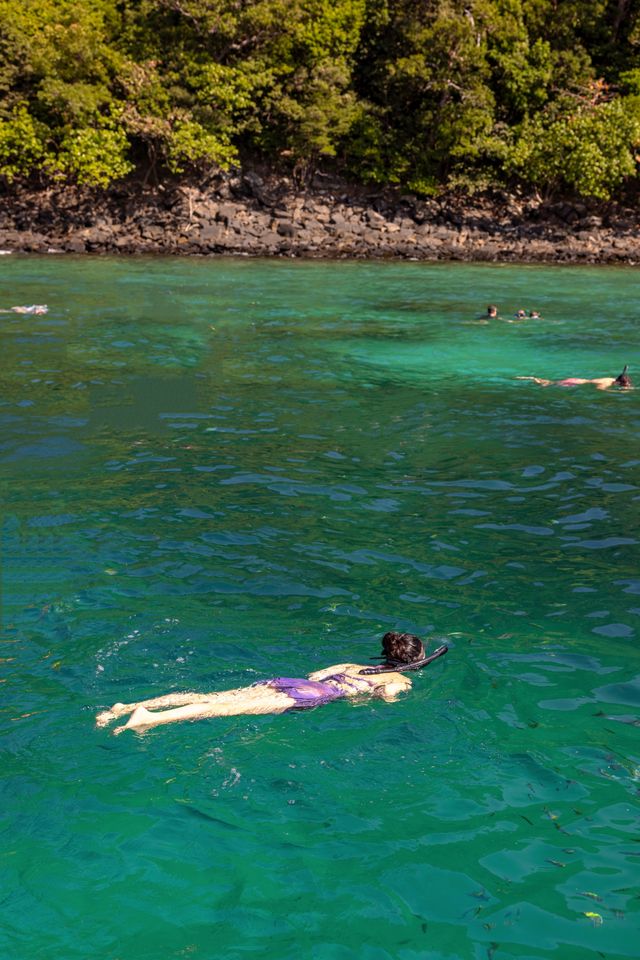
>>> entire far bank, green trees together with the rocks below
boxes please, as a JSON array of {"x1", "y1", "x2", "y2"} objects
[{"x1": 0, "y1": 0, "x2": 640, "y2": 263}]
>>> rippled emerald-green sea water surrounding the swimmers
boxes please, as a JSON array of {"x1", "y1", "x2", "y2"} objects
[{"x1": 0, "y1": 258, "x2": 640, "y2": 960}]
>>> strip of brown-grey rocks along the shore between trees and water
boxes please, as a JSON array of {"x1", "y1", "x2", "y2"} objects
[{"x1": 0, "y1": 171, "x2": 640, "y2": 264}]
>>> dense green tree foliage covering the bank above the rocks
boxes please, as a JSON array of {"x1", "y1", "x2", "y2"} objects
[{"x1": 0, "y1": 0, "x2": 640, "y2": 199}]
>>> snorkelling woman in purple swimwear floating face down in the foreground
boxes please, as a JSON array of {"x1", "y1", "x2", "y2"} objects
[{"x1": 96, "y1": 631, "x2": 447, "y2": 733}]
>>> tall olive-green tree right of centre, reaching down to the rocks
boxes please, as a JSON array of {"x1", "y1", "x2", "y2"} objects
[{"x1": 351, "y1": 0, "x2": 495, "y2": 191}]
